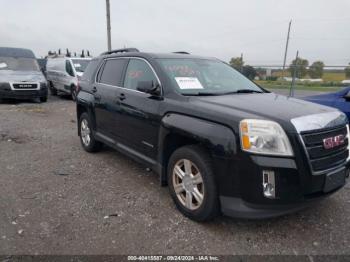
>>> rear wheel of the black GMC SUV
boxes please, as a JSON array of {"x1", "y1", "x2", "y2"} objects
[{"x1": 79, "y1": 113, "x2": 102, "y2": 153}]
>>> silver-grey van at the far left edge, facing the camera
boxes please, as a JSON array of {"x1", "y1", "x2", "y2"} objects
[{"x1": 0, "y1": 47, "x2": 48, "y2": 102}]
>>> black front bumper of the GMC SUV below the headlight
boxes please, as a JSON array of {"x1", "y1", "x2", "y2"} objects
[{"x1": 220, "y1": 156, "x2": 349, "y2": 219}]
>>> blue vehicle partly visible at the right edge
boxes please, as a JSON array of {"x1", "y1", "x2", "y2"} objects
[{"x1": 303, "y1": 87, "x2": 350, "y2": 119}]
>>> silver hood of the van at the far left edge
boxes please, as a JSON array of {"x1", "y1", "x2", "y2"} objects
[{"x1": 0, "y1": 70, "x2": 46, "y2": 82}]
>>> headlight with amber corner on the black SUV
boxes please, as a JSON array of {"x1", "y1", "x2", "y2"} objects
[{"x1": 240, "y1": 119, "x2": 293, "y2": 156}]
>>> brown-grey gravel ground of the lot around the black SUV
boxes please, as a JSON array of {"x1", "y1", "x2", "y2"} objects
[{"x1": 0, "y1": 90, "x2": 350, "y2": 255}]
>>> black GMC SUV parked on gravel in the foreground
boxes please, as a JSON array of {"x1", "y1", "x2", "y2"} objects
[{"x1": 77, "y1": 49, "x2": 349, "y2": 221}]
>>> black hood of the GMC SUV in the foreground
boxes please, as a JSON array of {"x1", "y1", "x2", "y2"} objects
[{"x1": 191, "y1": 93, "x2": 338, "y2": 128}]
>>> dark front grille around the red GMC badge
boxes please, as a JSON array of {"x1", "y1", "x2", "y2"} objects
[{"x1": 301, "y1": 126, "x2": 349, "y2": 172}]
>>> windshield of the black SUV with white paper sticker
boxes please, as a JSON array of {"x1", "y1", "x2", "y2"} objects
[{"x1": 159, "y1": 58, "x2": 264, "y2": 95}]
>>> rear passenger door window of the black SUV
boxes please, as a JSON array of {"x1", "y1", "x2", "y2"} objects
[{"x1": 99, "y1": 59, "x2": 128, "y2": 87}]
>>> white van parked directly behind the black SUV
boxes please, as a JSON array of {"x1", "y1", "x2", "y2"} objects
[{"x1": 46, "y1": 55, "x2": 91, "y2": 101}]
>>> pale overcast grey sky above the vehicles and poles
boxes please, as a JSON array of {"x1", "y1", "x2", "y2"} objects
[{"x1": 0, "y1": 0, "x2": 350, "y2": 65}]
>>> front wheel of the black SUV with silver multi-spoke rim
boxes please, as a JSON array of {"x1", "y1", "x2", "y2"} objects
[{"x1": 168, "y1": 146, "x2": 220, "y2": 221}]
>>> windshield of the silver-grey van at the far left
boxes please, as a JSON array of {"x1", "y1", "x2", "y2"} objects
[{"x1": 0, "y1": 57, "x2": 40, "y2": 71}]
